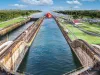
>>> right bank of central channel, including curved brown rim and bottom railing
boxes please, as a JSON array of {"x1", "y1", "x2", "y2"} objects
[{"x1": 54, "y1": 17, "x2": 99, "y2": 75}]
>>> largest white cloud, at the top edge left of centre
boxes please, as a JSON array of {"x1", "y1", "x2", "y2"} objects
[{"x1": 22, "y1": 0, "x2": 53, "y2": 5}]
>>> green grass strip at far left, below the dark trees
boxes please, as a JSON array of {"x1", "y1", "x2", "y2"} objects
[{"x1": 0, "y1": 17, "x2": 25, "y2": 28}]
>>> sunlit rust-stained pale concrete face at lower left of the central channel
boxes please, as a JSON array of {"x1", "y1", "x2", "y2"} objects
[{"x1": 0, "y1": 43, "x2": 26, "y2": 71}]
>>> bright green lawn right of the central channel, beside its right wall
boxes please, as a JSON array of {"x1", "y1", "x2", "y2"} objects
[{"x1": 60, "y1": 18, "x2": 100, "y2": 44}]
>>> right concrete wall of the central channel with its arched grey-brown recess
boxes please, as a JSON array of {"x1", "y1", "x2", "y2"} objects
[{"x1": 54, "y1": 17, "x2": 94, "y2": 67}]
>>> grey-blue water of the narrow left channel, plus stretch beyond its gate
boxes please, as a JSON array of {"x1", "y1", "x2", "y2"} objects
[{"x1": 0, "y1": 13, "x2": 44, "y2": 41}]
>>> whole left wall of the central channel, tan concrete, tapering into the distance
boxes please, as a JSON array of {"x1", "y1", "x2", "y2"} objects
[{"x1": 0, "y1": 17, "x2": 44, "y2": 73}]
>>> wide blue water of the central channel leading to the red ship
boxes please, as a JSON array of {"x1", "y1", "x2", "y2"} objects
[{"x1": 18, "y1": 19, "x2": 81, "y2": 75}]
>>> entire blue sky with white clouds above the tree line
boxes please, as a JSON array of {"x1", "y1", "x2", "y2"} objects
[{"x1": 0, "y1": 0, "x2": 100, "y2": 11}]
